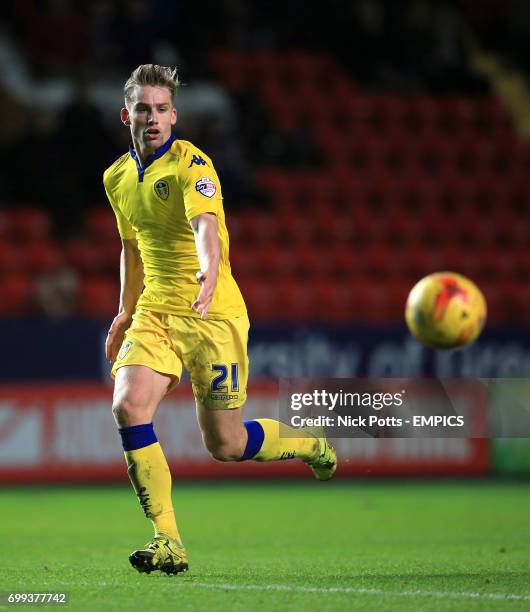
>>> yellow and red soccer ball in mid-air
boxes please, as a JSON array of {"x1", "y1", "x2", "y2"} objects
[{"x1": 405, "y1": 272, "x2": 487, "y2": 349}]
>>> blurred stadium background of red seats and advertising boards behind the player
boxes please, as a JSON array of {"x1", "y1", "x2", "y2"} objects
[{"x1": 0, "y1": 0, "x2": 530, "y2": 482}]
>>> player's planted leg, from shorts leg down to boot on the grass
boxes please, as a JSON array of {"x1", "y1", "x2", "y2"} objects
[{"x1": 112, "y1": 309, "x2": 187, "y2": 573}]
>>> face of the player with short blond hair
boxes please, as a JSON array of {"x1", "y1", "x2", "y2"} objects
[{"x1": 121, "y1": 85, "x2": 177, "y2": 153}]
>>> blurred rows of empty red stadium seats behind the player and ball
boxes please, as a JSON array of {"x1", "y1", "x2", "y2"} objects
[{"x1": 0, "y1": 2, "x2": 530, "y2": 323}]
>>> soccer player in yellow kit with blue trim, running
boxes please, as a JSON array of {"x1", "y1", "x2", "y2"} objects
[{"x1": 103, "y1": 64, "x2": 337, "y2": 574}]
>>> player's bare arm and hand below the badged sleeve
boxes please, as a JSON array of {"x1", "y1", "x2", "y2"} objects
[{"x1": 190, "y1": 213, "x2": 220, "y2": 320}]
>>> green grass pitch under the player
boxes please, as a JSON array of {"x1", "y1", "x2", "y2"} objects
[{"x1": 0, "y1": 481, "x2": 530, "y2": 612}]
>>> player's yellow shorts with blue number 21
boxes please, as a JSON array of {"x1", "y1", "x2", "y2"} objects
[{"x1": 111, "y1": 309, "x2": 249, "y2": 410}]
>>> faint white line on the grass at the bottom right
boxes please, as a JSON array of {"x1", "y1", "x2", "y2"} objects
[{"x1": 180, "y1": 580, "x2": 530, "y2": 601}]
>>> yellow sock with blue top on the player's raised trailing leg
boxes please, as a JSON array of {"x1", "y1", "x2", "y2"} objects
[{"x1": 241, "y1": 419, "x2": 318, "y2": 461}]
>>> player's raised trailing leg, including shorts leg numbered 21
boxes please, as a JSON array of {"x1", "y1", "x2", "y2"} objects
[{"x1": 184, "y1": 316, "x2": 336, "y2": 480}]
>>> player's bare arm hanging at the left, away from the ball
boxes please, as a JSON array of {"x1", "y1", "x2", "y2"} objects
[{"x1": 105, "y1": 239, "x2": 144, "y2": 363}]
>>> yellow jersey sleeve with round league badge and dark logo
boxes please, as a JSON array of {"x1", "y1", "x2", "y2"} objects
[{"x1": 177, "y1": 149, "x2": 223, "y2": 221}]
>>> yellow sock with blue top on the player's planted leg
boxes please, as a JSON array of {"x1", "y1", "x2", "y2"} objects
[{"x1": 120, "y1": 423, "x2": 180, "y2": 541}]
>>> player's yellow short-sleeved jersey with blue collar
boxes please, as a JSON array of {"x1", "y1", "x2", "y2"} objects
[{"x1": 103, "y1": 136, "x2": 246, "y2": 319}]
